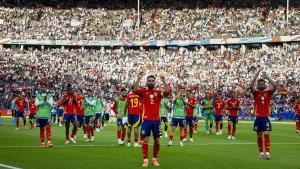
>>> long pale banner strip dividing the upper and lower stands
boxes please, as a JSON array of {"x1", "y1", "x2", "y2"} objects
[{"x1": 0, "y1": 35, "x2": 300, "y2": 47}]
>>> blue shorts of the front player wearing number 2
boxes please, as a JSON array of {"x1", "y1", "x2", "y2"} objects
[{"x1": 141, "y1": 120, "x2": 161, "y2": 138}]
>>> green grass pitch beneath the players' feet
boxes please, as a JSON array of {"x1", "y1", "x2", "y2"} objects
[{"x1": 0, "y1": 119, "x2": 300, "y2": 169}]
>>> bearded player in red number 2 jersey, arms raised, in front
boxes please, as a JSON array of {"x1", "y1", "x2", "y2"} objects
[{"x1": 133, "y1": 72, "x2": 170, "y2": 167}]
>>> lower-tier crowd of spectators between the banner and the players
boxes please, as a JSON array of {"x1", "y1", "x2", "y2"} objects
[{"x1": 0, "y1": 44, "x2": 300, "y2": 116}]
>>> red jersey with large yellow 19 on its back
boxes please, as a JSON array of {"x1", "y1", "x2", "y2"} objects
[{"x1": 127, "y1": 93, "x2": 142, "y2": 114}]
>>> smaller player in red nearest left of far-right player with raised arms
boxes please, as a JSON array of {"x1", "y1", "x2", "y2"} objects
[{"x1": 226, "y1": 92, "x2": 240, "y2": 140}]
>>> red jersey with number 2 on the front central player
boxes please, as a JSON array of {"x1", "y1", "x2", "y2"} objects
[{"x1": 135, "y1": 89, "x2": 170, "y2": 121}]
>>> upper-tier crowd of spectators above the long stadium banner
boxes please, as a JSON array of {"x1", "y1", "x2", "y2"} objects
[{"x1": 0, "y1": 1, "x2": 300, "y2": 41}]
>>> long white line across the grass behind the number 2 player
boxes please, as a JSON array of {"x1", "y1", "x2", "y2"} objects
[{"x1": 0, "y1": 142, "x2": 300, "y2": 148}]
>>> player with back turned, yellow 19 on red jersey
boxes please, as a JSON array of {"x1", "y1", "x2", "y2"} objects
[{"x1": 124, "y1": 89, "x2": 142, "y2": 147}]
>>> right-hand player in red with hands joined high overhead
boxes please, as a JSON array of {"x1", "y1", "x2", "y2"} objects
[{"x1": 250, "y1": 69, "x2": 277, "y2": 160}]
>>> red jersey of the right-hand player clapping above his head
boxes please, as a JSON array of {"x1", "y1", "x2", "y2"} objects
[{"x1": 254, "y1": 90, "x2": 273, "y2": 117}]
